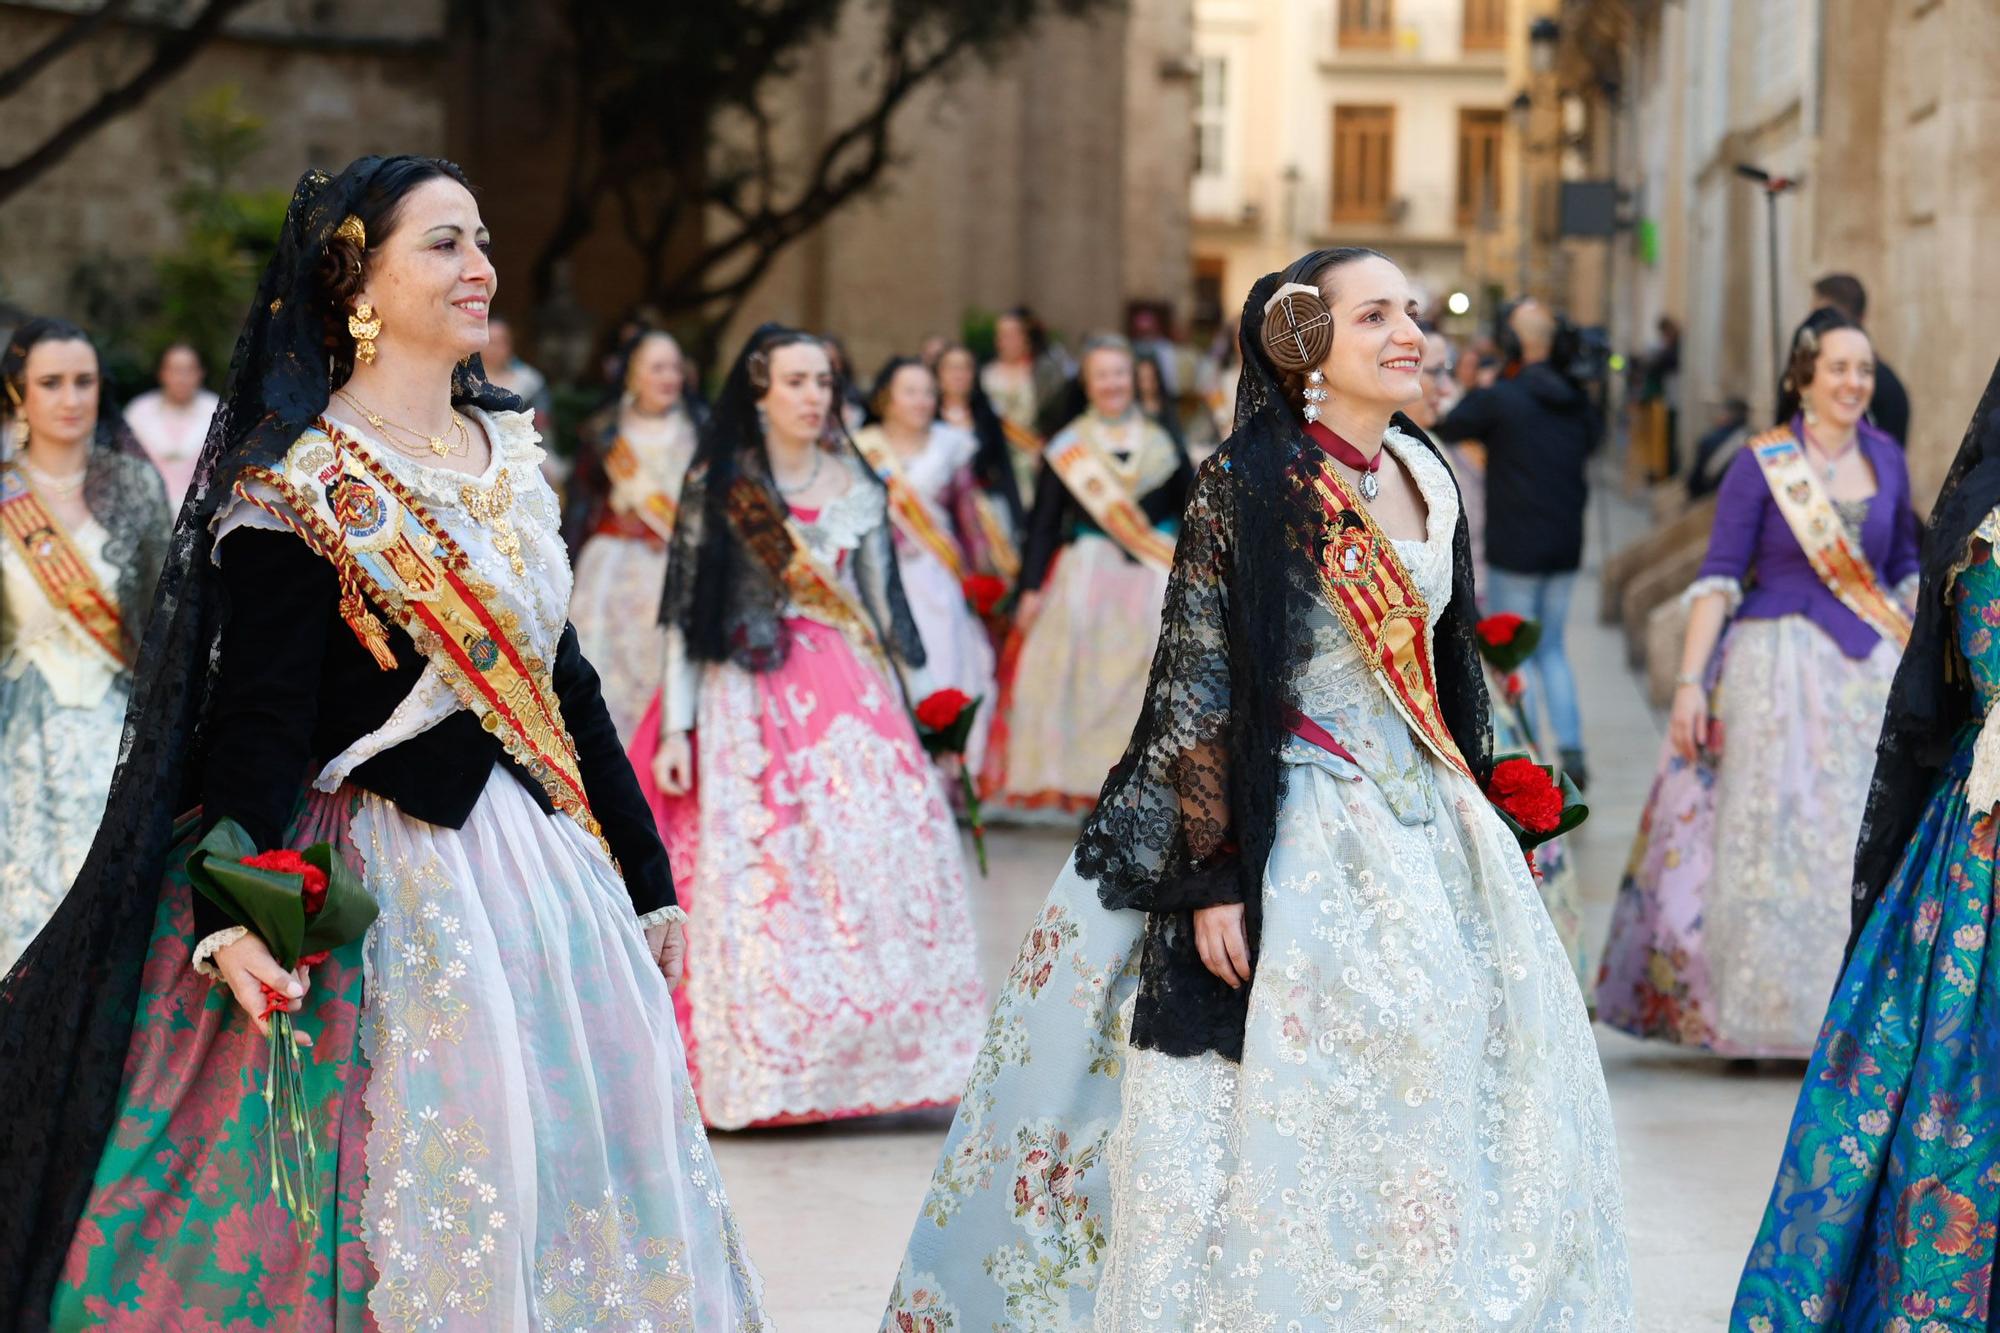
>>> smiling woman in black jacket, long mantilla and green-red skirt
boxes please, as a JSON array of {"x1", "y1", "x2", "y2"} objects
[{"x1": 0, "y1": 158, "x2": 764, "y2": 1333}]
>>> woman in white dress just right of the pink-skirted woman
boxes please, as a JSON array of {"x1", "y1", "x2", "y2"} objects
[{"x1": 854, "y1": 356, "x2": 996, "y2": 773}]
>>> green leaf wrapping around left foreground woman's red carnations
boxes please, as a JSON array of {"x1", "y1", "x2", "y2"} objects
[{"x1": 188, "y1": 819, "x2": 378, "y2": 971}]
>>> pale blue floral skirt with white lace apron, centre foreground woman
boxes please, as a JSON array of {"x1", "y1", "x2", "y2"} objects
[{"x1": 884, "y1": 761, "x2": 1632, "y2": 1333}]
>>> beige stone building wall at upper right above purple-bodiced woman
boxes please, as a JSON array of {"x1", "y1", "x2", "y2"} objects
[{"x1": 1564, "y1": 0, "x2": 2000, "y2": 508}]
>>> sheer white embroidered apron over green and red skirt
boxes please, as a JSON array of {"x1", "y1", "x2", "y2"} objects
[{"x1": 354, "y1": 769, "x2": 766, "y2": 1333}]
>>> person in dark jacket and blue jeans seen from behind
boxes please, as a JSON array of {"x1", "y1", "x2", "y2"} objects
[{"x1": 1432, "y1": 300, "x2": 1600, "y2": 787}]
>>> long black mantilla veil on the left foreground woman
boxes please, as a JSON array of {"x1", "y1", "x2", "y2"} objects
[{"x1": 0, "y1": 158, "x2": 520, "y2": 1329}]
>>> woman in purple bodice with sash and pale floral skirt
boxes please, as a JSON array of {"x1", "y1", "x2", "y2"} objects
[{"x1": 1598, "y1": 310, "x2": 1918, "y2": 1059}]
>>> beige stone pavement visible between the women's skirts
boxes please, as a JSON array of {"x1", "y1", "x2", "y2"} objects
[{"x1": 716, "y1": 472, "x2": 1800, "y2": 1333}]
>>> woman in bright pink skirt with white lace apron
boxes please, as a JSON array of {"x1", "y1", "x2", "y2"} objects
[{"x1": 632, "y1": 324, "x2": 986, "y2": 1129}]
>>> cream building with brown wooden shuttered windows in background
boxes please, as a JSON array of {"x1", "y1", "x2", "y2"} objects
[{"x1": 1192, "y1": 0, "x2": 1528, "y2": 324}]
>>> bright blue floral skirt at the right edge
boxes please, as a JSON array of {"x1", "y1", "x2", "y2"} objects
[{"x1": 1730, "y1": 733, "x2": 2000, "y2": 1333}]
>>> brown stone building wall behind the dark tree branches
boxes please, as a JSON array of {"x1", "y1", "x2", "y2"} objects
[{"x1": 704, "y1": 0, "x2": 1194, "y2": 376}]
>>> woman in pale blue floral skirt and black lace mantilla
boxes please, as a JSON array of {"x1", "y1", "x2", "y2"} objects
[{"x1": 884, "y1": 250, "x2": 1632, "y2": 1333}]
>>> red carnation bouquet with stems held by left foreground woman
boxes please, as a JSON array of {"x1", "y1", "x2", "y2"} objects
[{"x1": 188, "y1": 819, "x2": 376, "y2": 1231}]
